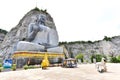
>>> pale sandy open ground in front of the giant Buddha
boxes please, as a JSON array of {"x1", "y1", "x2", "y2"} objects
[{"x1": 0, "y1": 63, "x2": 120, "y2": 80}]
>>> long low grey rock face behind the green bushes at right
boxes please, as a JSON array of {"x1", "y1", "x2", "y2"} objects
[{"x1": 65, "y1": 36, "x2": 120, "y2": 57}]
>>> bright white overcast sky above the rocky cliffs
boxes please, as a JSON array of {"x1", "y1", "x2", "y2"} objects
[{"x1": 0, "y1": 0, "x2": 120, "y2": 42}]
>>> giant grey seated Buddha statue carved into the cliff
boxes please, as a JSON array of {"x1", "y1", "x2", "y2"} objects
[{"x1": 16, "y1": 14, "x2": 63, "y2": 53}]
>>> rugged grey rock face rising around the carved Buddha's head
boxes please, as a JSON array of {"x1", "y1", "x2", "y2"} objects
[{"x1": 0, "y1": 9, "x2": 57, "y2": 59}]
